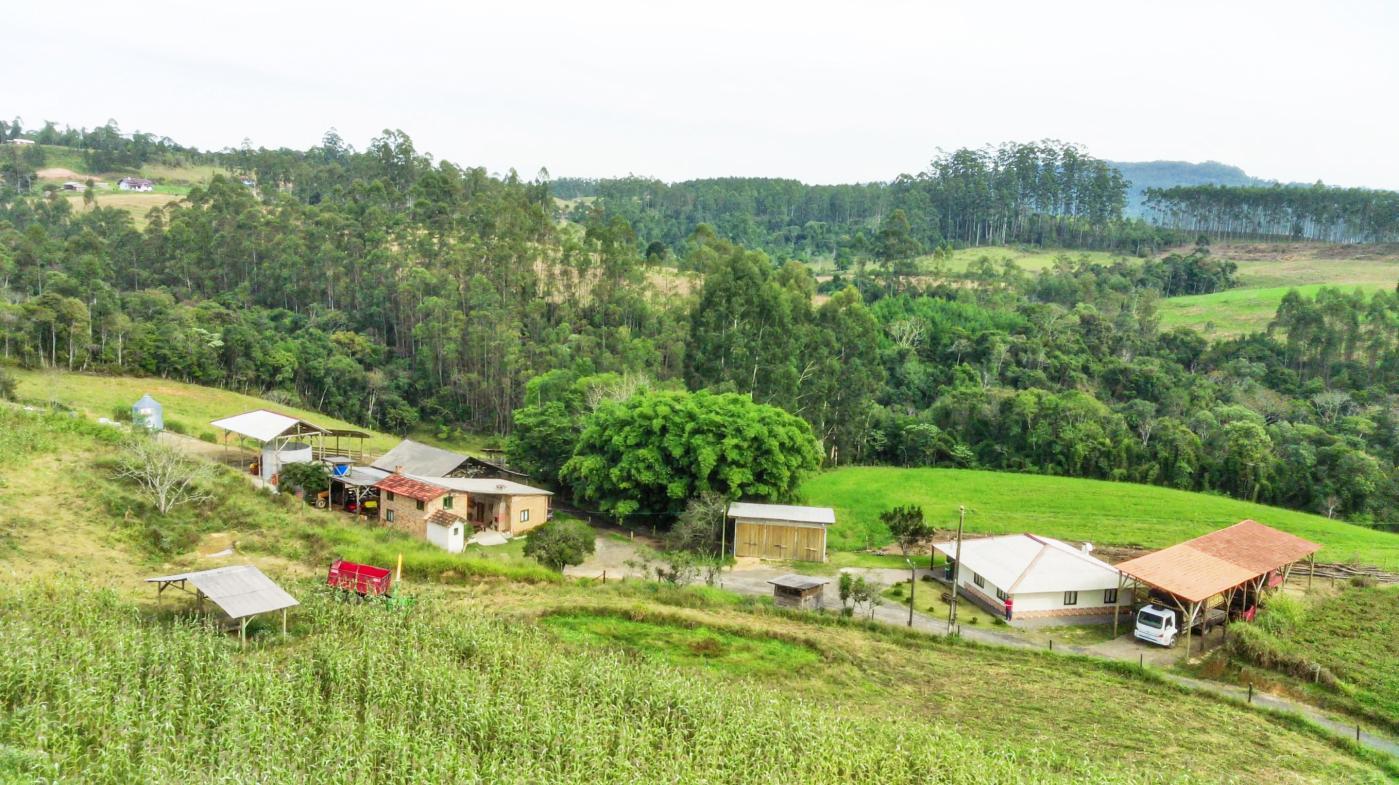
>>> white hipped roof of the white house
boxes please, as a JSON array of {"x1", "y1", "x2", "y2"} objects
[{"x1": 933, "y1": 535, "x2": 1118, "y2": 595}]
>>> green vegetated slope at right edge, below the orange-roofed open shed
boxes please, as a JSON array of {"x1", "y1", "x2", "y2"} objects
[{"x1": 1228, "y1": 585, "x2": 1399, "y2": 732}]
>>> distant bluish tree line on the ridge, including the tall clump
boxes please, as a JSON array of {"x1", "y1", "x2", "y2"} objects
[{"x1": 551, "y1": 141, "x2": 1175, "y2": 263}]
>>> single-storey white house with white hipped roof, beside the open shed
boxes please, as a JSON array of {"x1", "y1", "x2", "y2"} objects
[{"x1": 933, "y1": 533, "x2": 1132, "y2": 624}]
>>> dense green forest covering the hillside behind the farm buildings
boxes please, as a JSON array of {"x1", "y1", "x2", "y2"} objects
[{"x1": 0, "y1": 121, "x2": 1399, "y2": 523}]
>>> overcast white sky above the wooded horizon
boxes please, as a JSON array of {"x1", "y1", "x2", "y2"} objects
[{"x1": 0, "y1": 0, "x2": 1399, "y2": 189}]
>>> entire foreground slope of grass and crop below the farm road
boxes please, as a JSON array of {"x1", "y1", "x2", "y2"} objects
[{"x1": 0, "y1": 409, "x2": 1399, "y2": 784}]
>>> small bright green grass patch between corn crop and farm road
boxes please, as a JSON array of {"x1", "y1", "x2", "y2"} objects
[{"x1": 543, "y1": 613, "x2": 821, "y2": 677}]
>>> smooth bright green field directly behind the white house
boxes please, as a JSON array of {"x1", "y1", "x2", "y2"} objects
[{"x1": 800, "y1": 466, "x2": 1399, "y2": 570}]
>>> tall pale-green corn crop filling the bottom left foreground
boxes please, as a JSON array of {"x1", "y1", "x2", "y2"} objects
[{"x1": 0, "y1": 581, "x2": 1214, "y2": 785}]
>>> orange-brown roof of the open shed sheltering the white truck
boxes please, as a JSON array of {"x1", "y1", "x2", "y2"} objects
[{"x1": 1118, "y1": 521, "x2": 1321, "y2": 602}]
